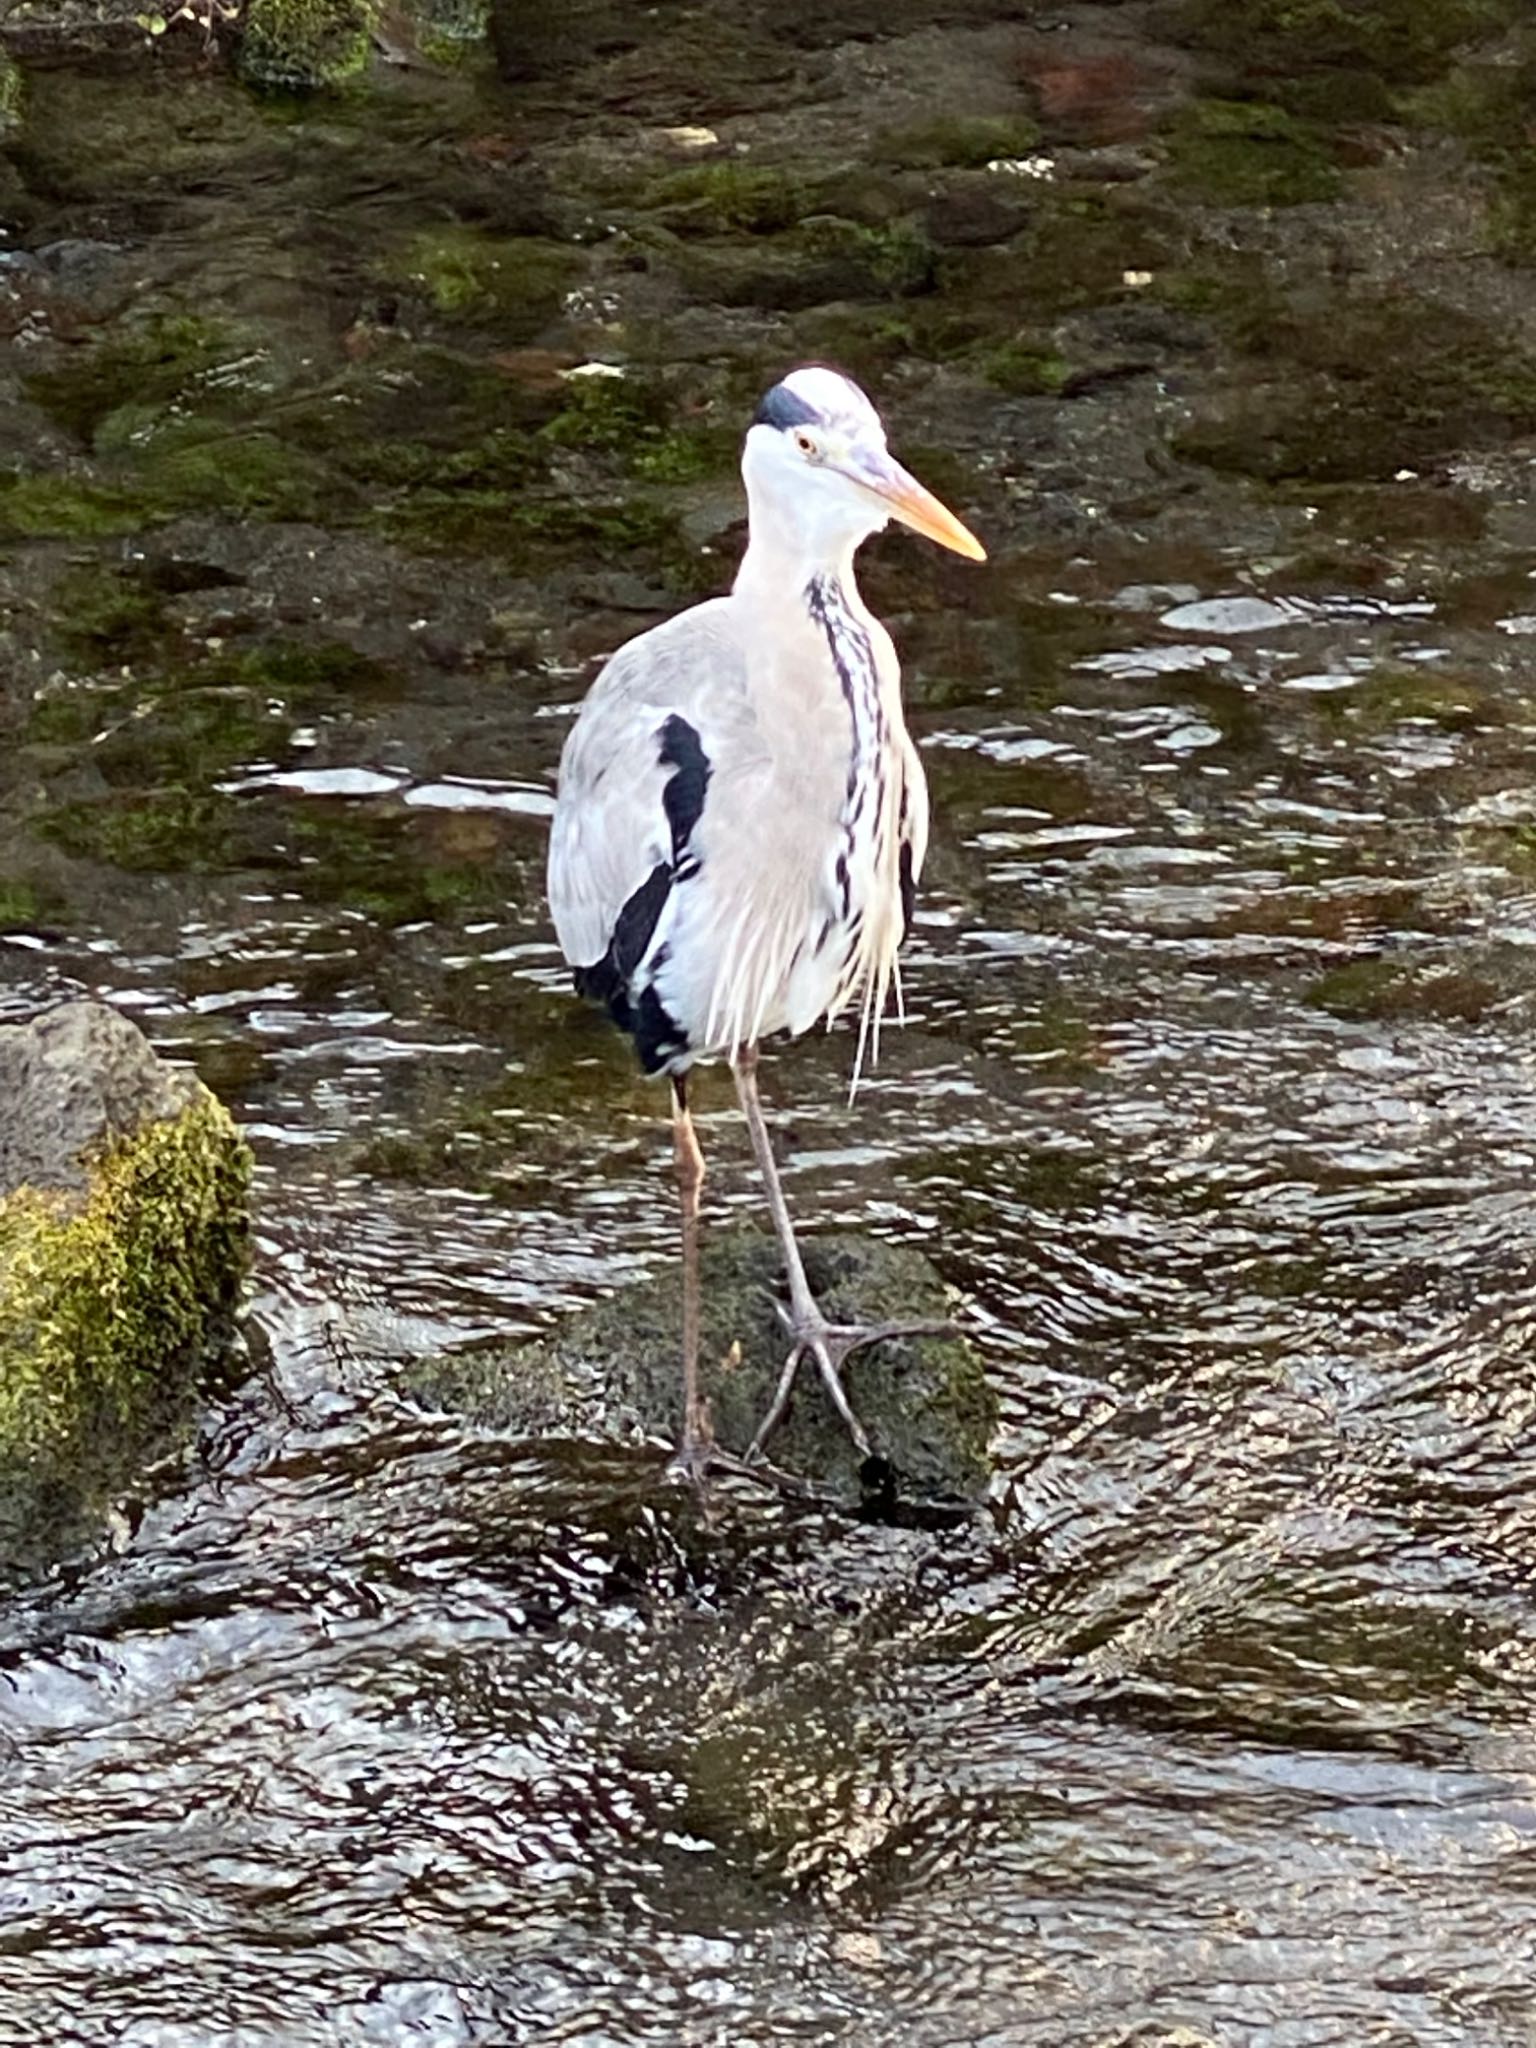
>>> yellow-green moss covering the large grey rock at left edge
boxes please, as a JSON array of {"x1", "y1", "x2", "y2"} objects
[{"x1": 0, "y1": 1087, "x2": 250, "y2": 1458}]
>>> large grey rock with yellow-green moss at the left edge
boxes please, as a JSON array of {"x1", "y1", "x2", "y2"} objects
[{"x1": 0, "y1": 1004, "x2": 250, "y2": 1573}]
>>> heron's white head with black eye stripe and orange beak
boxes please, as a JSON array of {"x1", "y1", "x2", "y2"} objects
[{"x1": 741, "y1": 365, "x2": 987, "y2": 561}]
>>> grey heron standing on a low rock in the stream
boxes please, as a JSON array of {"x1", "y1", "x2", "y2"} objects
[{"x1": 549, "y1": 365, "x2": 985, "y2": 1479}]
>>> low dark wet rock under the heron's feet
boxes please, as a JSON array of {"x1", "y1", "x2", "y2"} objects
[{"x1": 406, "y1": 1231, "x2": 997, "y2": 1505}]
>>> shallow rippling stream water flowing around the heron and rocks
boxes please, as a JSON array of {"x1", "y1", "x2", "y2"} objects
[{"x1": 0, "y1": 8, "x2": 1536, "y2": 2048}]
